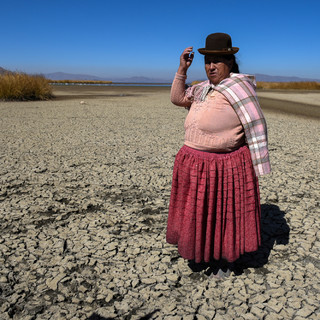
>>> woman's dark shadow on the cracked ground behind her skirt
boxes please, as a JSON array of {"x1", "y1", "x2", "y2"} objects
[{"x1": 189, "y1": 204, "x2": 290, "y2": 275}]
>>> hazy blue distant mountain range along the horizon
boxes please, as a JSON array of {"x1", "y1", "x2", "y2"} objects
[{"x1": 0, "y1": 67, "x2": 320, "y2": 83}]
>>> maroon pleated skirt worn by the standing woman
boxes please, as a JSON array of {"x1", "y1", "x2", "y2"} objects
[{"x1": 166, "y1": 146, "x2": 261, "y2": 263}]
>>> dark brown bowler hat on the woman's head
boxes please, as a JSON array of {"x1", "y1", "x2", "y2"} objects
[{"x1": 198, "y1": 33, "x2": 239, "y2": 55}]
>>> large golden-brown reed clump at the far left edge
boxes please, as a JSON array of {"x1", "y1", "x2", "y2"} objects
[{"x1": 0, "y1": 72, "x2": 53, "y2": 101}]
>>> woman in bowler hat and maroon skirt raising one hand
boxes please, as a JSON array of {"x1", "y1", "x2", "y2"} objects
[{"x1": 166, "y1": 33, "x2": 270, "y2": 276}]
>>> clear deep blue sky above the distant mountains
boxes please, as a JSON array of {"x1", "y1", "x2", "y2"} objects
[{"x1": 0, "y1": 0, "x2": 320, "y2": 79}]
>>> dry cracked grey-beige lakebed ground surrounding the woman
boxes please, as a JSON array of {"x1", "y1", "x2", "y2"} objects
[{"x1": 0, "y1": 87, "x2": 320, "y2": 320}]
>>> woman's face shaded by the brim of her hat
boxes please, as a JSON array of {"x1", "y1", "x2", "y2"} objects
[{"x1": 204, "y1": 55, "x2": 233, "y2": 85}]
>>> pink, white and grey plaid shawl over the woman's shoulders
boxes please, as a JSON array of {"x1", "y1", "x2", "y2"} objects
[{"x1": 186, "y1": 73, "x2": 271, "y2": 176}]
